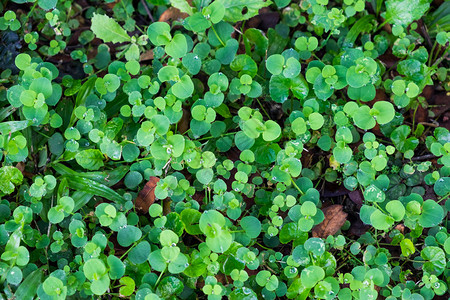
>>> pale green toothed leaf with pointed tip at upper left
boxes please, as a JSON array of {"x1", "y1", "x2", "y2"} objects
[{"x1": 91, "y1": 13, "x2": 131, "y2": 43}]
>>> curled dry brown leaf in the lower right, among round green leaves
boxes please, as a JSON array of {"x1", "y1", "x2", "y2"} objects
[{"x1": 312, "y1": 204, "x2": 347, "y2": 238}]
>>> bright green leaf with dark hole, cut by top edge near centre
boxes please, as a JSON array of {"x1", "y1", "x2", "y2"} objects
[{"x1": 217, "y1": 0, "x2": 272, "y2": 23}]
